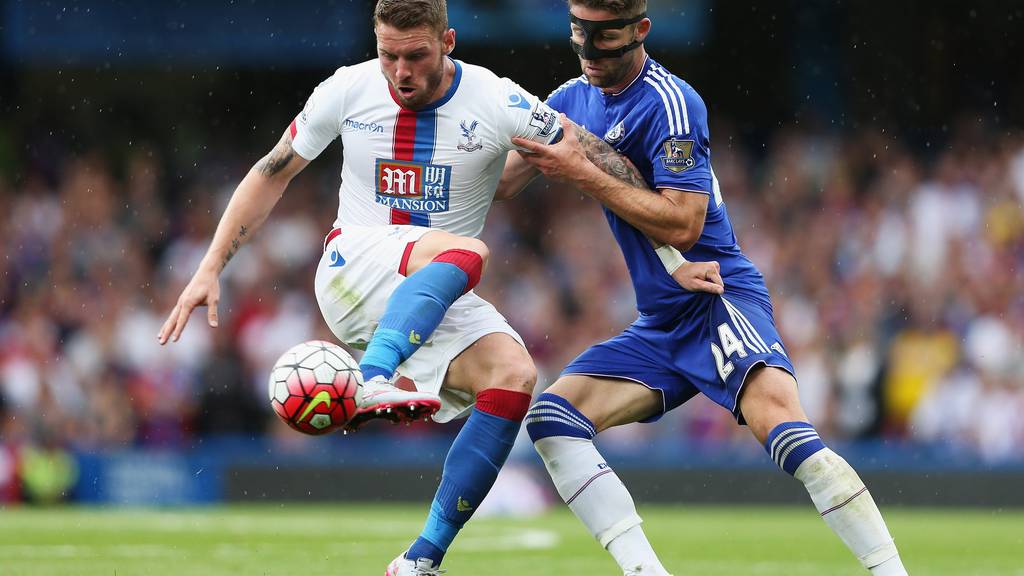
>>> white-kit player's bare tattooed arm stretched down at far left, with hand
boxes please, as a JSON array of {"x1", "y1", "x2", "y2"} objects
[{"x1": 157, "y1": 130, "x2": 309, "y2": 344}]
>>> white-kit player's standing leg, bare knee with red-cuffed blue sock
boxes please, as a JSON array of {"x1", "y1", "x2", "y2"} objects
[{"x1": 407, "y1": 333, "x2": 537, "y2": 567}]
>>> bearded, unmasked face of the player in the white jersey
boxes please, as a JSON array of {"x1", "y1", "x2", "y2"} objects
[{"x1": 375, "y1": 24, "x2": 455, "y2": 109}]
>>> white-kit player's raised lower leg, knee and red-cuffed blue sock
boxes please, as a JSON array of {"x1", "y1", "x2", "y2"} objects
[{"x1": 359, "y1": 231, "x2": 488, "y2": 380}]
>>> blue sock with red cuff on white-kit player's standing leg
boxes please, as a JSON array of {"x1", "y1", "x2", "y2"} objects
[{"x1": 406, "y1": 388, "x2": 529, "y2": 566}]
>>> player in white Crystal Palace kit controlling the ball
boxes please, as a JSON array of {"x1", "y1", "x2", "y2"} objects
[{"x1": 159, "y1": 0, "x2": 721, "y2": 576}]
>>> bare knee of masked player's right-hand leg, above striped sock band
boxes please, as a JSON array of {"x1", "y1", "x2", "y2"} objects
[{"x1": 739, "y1": 365, "x2": 807, "y2": 444}]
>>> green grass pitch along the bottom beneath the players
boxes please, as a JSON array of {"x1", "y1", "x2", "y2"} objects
[{"x1": 0, "y1": 504, "x2": 1024, "y2": 576}]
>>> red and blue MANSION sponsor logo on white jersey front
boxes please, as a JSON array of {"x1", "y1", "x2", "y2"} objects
[{"x1": 376, "y1": 159, "x2": 452, "y2": 212}]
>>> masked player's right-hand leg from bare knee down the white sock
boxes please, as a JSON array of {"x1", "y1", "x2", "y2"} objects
[{"x1": 739, "y1": 367, "x2": 906, "y2": 576}]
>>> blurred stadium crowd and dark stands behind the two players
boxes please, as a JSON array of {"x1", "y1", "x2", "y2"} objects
[{"x1": 0, "y1": 0, "x2": 1024, "y2": 516}]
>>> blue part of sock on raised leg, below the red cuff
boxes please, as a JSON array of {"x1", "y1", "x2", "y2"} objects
[{"x1": 359, "y1": 261, "x2": 469, "y2": 381}]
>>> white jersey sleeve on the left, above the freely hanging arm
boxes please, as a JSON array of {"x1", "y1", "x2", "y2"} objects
[{"x1": 290, "y1": 68, "x2": 349, "y2": 160}]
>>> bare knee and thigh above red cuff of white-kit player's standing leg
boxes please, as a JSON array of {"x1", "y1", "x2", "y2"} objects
[{"x1": 443, "y1": 332, "x2": 537, "y2": 397}]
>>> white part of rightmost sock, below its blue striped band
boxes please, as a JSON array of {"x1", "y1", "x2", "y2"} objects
[{"x1": 793, "y1": 448, "x2": 906, "y2": 576}]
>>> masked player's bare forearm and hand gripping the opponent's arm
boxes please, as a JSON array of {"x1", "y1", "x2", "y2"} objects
[{"x1": 512, "y1": 115, "x2": 708, "y2": 251}]
